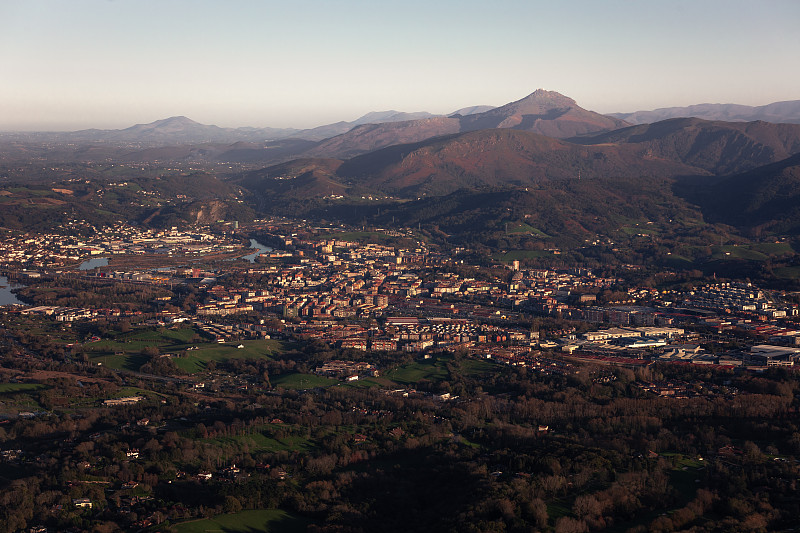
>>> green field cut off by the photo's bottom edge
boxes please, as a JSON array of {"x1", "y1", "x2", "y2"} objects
[{"x1": 174, "y1": 509, "x2": 311, "y2": 533}]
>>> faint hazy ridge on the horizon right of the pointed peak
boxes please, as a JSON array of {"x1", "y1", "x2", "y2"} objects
[{"x1": 609, "y1": 100, "x2": 800, "y2": 124}]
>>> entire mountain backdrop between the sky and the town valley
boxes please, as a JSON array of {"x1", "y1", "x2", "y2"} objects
[{"x1": 0, "y1": 89, "x2": 800, "y2": 242}]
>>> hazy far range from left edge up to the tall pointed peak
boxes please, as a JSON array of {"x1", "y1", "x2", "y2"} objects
[{"x1": 0, "y1": 89, "x2": 628, "y2": 165}]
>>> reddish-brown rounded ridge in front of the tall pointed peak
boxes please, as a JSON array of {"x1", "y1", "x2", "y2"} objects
[{"x1": 243, "y1": 119, "x2": 800, "y2": 198}]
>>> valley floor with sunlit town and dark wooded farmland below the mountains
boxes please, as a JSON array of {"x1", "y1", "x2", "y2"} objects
[{"x1": 0, "y1": 210, "x2": 800, "y2": 533}]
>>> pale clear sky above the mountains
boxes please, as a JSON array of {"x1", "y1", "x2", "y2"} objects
[{"x1": 0, "y1": 0, "x2": 800, "y2": 131}]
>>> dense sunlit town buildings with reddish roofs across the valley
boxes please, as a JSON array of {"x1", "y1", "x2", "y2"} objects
[{"x1": 2, "y1": 218, "x2": 800, "y2": 372}]
